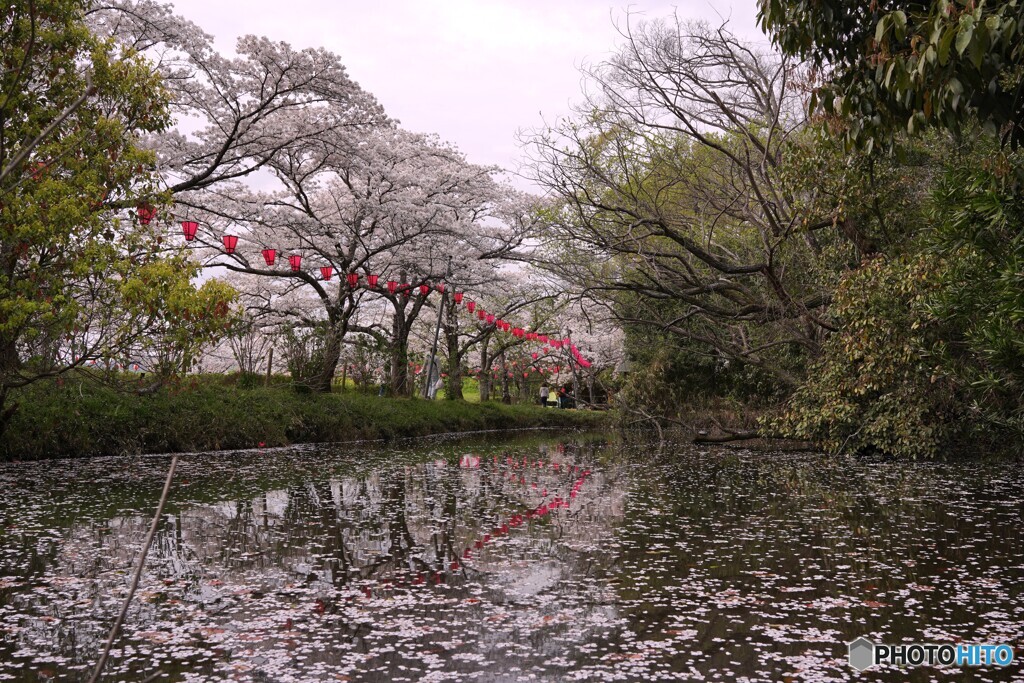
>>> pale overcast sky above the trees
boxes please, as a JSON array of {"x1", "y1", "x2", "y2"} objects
[{"x1": 165, "y1": 0, "x2": 766, "y2": 181}]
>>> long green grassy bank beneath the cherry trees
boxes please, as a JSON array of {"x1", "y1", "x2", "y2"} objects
[{"x1": 0, "y1": 379, "x2": 607, "y2": 460}]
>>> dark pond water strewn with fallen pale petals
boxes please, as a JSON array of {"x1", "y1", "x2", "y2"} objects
[{"x1": 0, "y1": 435, "x2": 1024, "y2": 682}]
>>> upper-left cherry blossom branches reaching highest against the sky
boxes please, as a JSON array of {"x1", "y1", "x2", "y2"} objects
[{"x1": 88, "y1": 0, "x2": 388, "y2": 196}]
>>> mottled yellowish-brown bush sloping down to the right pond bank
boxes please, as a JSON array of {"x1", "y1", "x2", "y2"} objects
[{"x1": 767, "y1": 255, "x2": 963, "y2": 458}]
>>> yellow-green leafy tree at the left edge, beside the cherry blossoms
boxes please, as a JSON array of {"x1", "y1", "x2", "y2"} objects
[{"x1": 0, "y1": 0, "x2": 234, "y2": 409}]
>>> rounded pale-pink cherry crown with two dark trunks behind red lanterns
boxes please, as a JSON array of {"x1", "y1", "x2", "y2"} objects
[{"x1": 188, "y1": 126, "x2": 524, "y2": 393}]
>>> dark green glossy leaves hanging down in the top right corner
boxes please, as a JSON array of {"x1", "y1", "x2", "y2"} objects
[{"x1": 760, "y1": 0, "x2": 1024, "y2": 152}]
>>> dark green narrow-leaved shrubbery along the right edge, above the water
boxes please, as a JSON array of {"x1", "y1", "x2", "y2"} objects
[{"x1": 931, "y1": 144, "x2": 1024, "y2": 442}]
